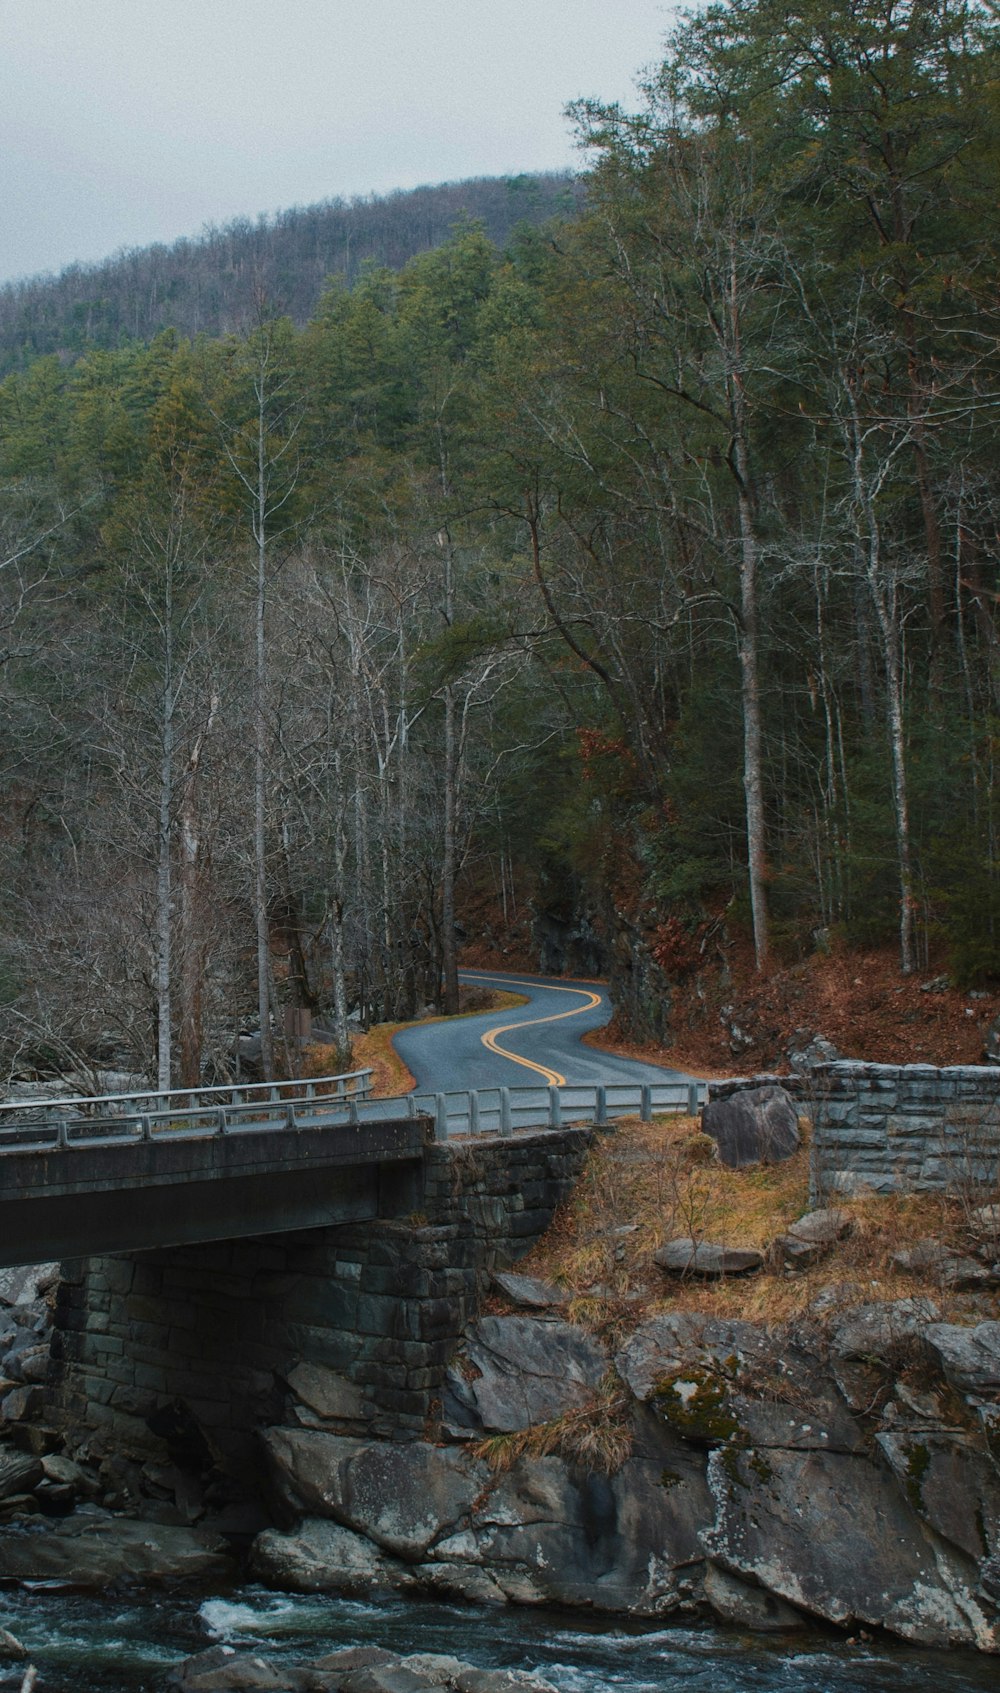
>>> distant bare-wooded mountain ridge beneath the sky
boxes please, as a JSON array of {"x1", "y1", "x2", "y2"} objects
[{"x1": 0, "y1": 173, "x2": 582, "y2": 376}]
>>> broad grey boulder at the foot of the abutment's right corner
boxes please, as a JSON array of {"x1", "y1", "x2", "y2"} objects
[{"x1": 264, "y1": 1429, "x2": 489, "y2": 1558}]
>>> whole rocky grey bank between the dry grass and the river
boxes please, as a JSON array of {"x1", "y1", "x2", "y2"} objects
[{"x1": 254, "y1": 1299, "x2": 1000, "y2": 1652}]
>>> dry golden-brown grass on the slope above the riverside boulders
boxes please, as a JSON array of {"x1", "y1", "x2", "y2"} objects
[{"x1": 519, "y1": 1117, "x2": 1000, "y2": 1341}]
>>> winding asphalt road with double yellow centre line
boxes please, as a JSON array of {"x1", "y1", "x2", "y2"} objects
[{"x1": 393, "y1": 970, "x2": 687, "y2": 1092}]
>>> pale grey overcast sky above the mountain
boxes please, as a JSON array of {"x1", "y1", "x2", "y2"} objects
[{"x1": 0, "y1": 0, "x2": 673, "y2": 279}]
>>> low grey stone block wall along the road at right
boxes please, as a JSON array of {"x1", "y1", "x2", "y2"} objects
[{"x1": 709, "y1": 1058, "x2": 1000, "y2": 1200}]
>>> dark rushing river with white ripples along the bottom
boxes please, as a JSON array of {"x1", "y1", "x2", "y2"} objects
[{"x1": 0, "y1": 1586, "x2": 997, "y2": 1693}]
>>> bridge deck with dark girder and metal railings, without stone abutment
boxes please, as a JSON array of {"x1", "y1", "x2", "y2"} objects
[{"x1": 0, "y1": 1070, "x2": 704, "y2": 1268}]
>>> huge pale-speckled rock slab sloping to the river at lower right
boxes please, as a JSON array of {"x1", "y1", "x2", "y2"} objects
[{"x1": 702, "y1": 1446, "x2": 1000, "y2": 1651}]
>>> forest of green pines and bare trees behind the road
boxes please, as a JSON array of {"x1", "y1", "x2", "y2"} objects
[{"x1": 0, "y1": 0, "x2": 1000, "y2": 1087}]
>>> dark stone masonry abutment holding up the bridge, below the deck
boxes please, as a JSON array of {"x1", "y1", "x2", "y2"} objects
[{"x1": 49, "y1": 1129, "x2": 592, "y2": 1481}]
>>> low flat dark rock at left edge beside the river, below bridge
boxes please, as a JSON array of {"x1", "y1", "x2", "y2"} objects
[{"x1": 0, "y1": 1515, "x2": 235, "y2": 1588}]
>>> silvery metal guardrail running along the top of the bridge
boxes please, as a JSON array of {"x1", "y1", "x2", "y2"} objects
[{"x1": 0, "y1": 1070, "x2": 706, "y2": 1156}]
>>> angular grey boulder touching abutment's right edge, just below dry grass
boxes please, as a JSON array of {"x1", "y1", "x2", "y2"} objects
[{"x1": 445, "y1": 1315, "x2": 609, "y2": 1432}]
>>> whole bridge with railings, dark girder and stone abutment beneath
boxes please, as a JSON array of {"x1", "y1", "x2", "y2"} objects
[{"x1": 0, "y1": 1078, "x2": 689, "y2": 1492}]
